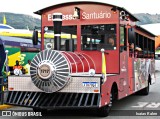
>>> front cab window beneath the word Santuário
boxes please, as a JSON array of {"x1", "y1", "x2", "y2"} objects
[{"x1": 81, "y1": 24, "x2": 116, "y2": 50}]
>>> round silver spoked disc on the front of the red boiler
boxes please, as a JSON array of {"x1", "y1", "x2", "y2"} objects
[{"x1": 30, "y1": 49, "x2": 70, "y2": 93}]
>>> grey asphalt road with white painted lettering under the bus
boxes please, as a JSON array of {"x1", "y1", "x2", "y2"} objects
[{"x1": 0, "y1": 72, "x2": 160, "y2": 119}]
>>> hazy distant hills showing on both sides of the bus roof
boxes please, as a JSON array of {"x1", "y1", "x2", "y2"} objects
[{"x1": 0, "y1": 12, "x2": 160, "y2": 30}]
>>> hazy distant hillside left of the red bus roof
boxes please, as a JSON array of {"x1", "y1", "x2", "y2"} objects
[{"x1": 0, "y1": 12, "x2": 41, "y2": 30}]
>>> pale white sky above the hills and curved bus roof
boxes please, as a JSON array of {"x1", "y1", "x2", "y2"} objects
[{"x1": 0, "y1": 0, "x2": 160, "y2": 17}]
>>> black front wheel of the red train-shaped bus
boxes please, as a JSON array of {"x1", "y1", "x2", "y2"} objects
[{"x1": 98, "y1": 93, "x2": 113, "y2": 117}]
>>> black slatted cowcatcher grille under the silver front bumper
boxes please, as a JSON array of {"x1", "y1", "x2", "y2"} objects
[{"x1": 5, "y1": 91, "x2": 100, "y2": 109}]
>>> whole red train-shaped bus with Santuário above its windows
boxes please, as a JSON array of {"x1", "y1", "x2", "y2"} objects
[{"x1": 5, "y1": 2, "x2": 155, "y2": 116}]
